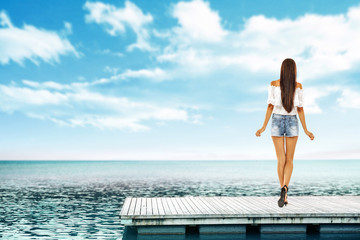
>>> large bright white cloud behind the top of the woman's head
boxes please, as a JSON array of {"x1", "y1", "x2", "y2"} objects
[{"x1": 233, "y1": 10, "x2": 360, "y2": 80}]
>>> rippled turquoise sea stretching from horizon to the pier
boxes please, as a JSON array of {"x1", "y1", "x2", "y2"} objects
[{"x1": 0, "y1": 160, "x2": 360, "y2": 239}]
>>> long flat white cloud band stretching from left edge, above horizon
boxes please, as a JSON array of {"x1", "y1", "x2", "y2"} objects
[{"x1": 0, "y1": 80, "x2": 201, "y2": 131}]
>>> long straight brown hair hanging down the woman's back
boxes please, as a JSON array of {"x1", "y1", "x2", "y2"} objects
[{"x1": 280, "y1": 58, "x2": 296, "y2": 112}]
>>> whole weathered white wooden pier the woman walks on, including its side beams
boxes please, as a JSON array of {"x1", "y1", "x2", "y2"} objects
[{"x1": 120, "y1": 196, "x2": 360, "y2": 234}]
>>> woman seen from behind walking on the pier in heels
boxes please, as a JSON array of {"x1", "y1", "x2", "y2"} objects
[{"x1": 256, "y1": 58, "x2": 314, "y2": 207}]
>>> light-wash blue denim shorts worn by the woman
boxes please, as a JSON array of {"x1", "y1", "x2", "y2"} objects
[{"x1": 271, "y1": 113, "x2": 299, "y2": 137}]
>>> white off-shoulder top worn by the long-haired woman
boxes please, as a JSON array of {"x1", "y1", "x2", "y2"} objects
[{"x1": 267, "y1": 85, "x2": 303, "y2": 115}]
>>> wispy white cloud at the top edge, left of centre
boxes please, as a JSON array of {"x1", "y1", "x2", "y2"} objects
[{"x1": 84, "y1": 0, "x2": 156, "y2": 51}]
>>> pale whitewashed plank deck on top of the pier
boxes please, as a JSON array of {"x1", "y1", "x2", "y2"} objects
[{"x1": 120, "y1": 196, "x2": 360, "y2": 224}]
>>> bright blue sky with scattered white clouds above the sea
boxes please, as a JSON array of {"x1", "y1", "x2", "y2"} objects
[{"x1": 0, "y1": 0, "x2": 360, "y2": 160}]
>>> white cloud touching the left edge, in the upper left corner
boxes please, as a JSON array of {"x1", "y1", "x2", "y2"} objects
[{"x1": 0, "y1": 11, "x2": 80, "y2": 65}]
